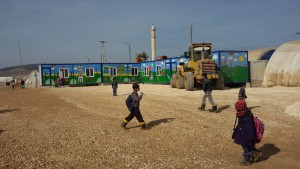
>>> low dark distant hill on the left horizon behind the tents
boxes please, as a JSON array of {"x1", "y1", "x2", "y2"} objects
[{"x1": 0, "y1": 64, "x2": 39, "y2": 77}]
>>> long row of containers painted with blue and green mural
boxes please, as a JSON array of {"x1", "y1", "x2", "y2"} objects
[{"x1": 40, "y1": 51, "x2": 249, "y2": 86}]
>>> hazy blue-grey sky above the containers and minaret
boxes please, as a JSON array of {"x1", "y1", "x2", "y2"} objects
[{"x1": 0, "y1": 0, "x2": 300, "y2": 69}]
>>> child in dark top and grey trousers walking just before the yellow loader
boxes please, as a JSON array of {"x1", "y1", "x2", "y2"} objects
[{"x1": 198, "y1": 73, "x2": 217, "y2": 112}]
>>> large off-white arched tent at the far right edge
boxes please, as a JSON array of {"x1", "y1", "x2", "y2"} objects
[{"x1": 263, "y1": 41, "x2": 300, "y2": 87}]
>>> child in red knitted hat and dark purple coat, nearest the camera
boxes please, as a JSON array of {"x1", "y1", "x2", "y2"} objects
[{"x1": 234, "y1": 100, "x2": 260, "y2": 165}]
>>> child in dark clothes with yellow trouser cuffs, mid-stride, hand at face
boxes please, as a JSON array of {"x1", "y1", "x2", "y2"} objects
[{"x1": 121, "y1": 83, "x2": 147, "y2": 129}]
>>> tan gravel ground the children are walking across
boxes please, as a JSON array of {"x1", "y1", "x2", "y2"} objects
[{"x1": 0, "y1": 84, "x2": 300, "y2": 169}]
